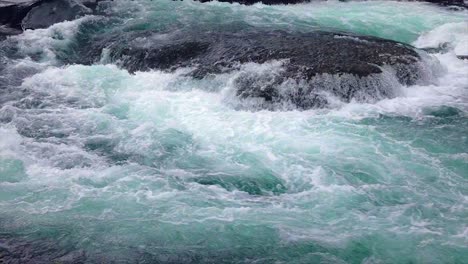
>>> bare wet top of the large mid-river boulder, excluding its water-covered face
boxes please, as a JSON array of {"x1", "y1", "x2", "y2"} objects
[{"x1": 99, "y1": 30, "x2": 419, "y2": 80}]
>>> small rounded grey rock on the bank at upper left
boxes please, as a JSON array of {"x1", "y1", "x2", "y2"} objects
[{"x1": 21, "y1": 0, "x2": 92, "y2": 29}]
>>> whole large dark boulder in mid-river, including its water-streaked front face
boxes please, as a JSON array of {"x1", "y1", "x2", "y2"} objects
[{"x1": 75, "y1": 29, "x2": 430, "y2": 109}]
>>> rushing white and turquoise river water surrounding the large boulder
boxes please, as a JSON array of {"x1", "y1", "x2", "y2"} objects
[{"x1": 0, "y1": 0, "x2": 468, "y2": 263}]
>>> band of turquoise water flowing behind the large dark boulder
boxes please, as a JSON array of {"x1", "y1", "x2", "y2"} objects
[{"x1": 108, "y1": 1, "x2": 467, "y2": 43}]
